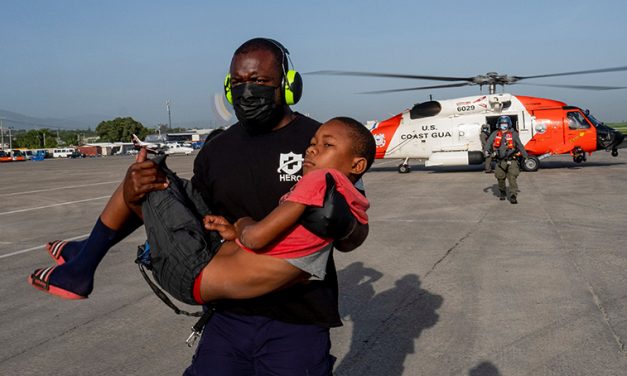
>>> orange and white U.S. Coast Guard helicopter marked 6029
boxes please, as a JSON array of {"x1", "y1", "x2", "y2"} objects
[{"x1": 311, "y1": 66, "x2": 627, "y2": 173}]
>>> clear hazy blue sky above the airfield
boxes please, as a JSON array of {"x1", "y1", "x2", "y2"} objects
[{"x1": 0, "y1": 0, "x2": 627, "y2": 127}]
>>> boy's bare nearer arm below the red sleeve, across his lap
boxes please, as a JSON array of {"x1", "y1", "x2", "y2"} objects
[{"x1": 235, "y1": 201, "x2": 306, "y2": 249}]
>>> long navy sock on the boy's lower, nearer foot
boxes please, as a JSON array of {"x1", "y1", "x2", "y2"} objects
[{"x1": 50, "y1": 218, "x2": 121, "y2": 296}]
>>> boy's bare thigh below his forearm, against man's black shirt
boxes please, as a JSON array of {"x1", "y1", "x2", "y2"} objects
[{"x1": 199, "y1": 241, "x2": 309, "y2": 302}]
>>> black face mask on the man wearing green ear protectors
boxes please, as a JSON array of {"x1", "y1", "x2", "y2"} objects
[{"x1": 231, "y1": 82, "x2": 284, "y2": 134}]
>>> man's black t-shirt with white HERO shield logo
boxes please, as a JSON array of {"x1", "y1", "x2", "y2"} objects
[{"x1": 192, "y1": 113, "x2": 342, "y2": 327}]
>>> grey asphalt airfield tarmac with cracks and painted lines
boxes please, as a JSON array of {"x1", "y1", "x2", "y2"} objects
[{"x1": 0, "y1": 152, "x2": 627, "y2": 376}]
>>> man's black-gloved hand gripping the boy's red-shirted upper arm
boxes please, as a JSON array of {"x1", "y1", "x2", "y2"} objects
[{"x1": 300, "y1": 173, "x2": 357, "y2": 240}]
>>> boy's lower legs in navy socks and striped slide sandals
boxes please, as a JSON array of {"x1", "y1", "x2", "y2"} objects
[{"x1": 29, "y1": 185, "x2": 141, "y2": 298}]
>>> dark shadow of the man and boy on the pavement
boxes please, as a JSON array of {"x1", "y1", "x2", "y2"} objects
[{"x1": 334, "y1": 262, "x2": 444, "y2": 376}]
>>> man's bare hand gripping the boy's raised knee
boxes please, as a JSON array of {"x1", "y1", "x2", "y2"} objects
[{"x1": 123, "y1": 148, "x2": 168, "y2": 212}]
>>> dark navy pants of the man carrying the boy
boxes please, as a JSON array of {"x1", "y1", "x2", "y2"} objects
[{"x1": 184, "y1": 312, "x2": 334, "y2": 376}]
